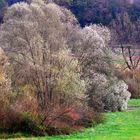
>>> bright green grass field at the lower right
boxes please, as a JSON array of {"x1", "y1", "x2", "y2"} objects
[{"x1": 3, "y1": 100, "x2": 140, "y2": 140}]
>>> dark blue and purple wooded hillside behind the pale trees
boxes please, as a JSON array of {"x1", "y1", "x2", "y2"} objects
[{"x1": 0, "y1": 0, "x2": 140, "y2": 45}]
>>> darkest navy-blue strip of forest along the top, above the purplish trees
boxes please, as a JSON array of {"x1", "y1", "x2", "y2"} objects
[{"x1": 0, "y1": 0, "x2": 140, "y2": 26}]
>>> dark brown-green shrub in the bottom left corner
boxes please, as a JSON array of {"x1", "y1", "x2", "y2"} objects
[{"x1": 0, "y1": 109, "x2": 45, "y2": 135}]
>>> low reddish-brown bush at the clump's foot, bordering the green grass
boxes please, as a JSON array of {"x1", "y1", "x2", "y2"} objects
[{"x1": 45, "y1": 106, "x2": 104, "y2": 135}]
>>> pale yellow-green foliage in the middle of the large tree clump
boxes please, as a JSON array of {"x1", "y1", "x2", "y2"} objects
[{"x1": 52, "y1": 49, "x2": 85, "y2": 98}]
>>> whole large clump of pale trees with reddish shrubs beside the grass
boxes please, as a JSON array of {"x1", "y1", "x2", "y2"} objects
[{"x1": 0, "y1": 0, "x2": 130, "y2": 135}]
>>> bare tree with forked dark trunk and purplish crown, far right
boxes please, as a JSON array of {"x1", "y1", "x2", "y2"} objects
[{"x1": 112, "y1": 13, "x2": 140, "y2": 71}]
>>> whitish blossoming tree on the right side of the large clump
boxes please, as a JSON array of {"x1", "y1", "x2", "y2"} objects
[{"x1": 70, "y1": 25, "x2": 130, "y2": 111}]
